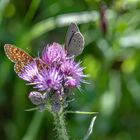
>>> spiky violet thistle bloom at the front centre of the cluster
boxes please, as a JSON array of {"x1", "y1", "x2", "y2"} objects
[{"x1": 35, "y1": 67, "x2": 62, "y2": 91}]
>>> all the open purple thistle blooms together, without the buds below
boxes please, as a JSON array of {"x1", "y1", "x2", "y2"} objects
[{"x1": 20, "y1": 43, "x2": 85, "y2": 98}]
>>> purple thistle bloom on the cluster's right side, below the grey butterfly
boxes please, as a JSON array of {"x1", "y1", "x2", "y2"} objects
[{"x1": 61, "y1": 59, "x2": 85, "y2": 87}]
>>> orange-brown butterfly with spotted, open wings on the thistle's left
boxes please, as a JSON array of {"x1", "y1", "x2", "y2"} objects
[{"x1": 4, "y1": 44, "x2": 47, "y2": 75}]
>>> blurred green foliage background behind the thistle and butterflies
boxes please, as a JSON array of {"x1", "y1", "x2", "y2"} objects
[{"x1": 0, "y1": 0, "x2": 140, "y2": 140}]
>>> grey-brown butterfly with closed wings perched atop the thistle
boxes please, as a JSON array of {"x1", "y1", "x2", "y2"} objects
[{"x1": 65, "y1": 23, "x2": 84, "y2": 56}]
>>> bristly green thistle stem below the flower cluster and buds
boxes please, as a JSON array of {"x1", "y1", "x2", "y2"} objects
[{"x1": 53, "y1": 108, "x2": 69, "y2": 140}]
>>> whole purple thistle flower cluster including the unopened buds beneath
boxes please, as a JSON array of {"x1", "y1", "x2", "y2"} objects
[{"x1": 15, "y1": 43, "x2": 86, "y2": 110}]
